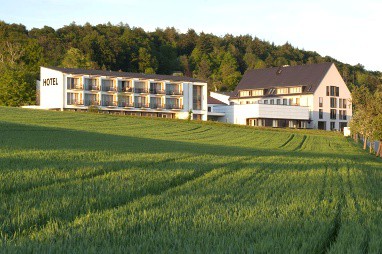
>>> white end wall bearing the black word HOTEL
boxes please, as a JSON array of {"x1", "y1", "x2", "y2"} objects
[{"x1": 40, "y1": 67, "x2": 65, "y2": 110}]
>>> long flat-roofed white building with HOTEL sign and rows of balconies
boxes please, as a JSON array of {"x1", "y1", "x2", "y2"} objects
[{"x1": 40, "y1": 67, "x2": 207, "y2": 120}]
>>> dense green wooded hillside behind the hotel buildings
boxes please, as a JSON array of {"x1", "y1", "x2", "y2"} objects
[{"x1": 0, "y1": 21, "x2": 382, "y2": 105}]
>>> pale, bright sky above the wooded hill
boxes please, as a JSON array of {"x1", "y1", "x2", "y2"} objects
[{"x1": 0, "y1": 0, "x2": 382, "y2": 71}]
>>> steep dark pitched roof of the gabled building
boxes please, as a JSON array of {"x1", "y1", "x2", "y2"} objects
[{"x1": 235, "y1": 63, "x2": 333, "y2": 94}]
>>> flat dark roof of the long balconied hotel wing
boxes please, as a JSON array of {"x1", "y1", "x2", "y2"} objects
[{"x1": 46, "y1": 67, "x2": 206, "y2": 83}]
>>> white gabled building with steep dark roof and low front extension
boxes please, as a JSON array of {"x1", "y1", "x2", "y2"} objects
[{"x1": 211, "y1": 63, "x2": 352, "y2": 130}]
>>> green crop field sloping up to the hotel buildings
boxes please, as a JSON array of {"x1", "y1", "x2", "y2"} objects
[{"x1": 0, "y1": 107, "x2": 382, "y2": 253}]
